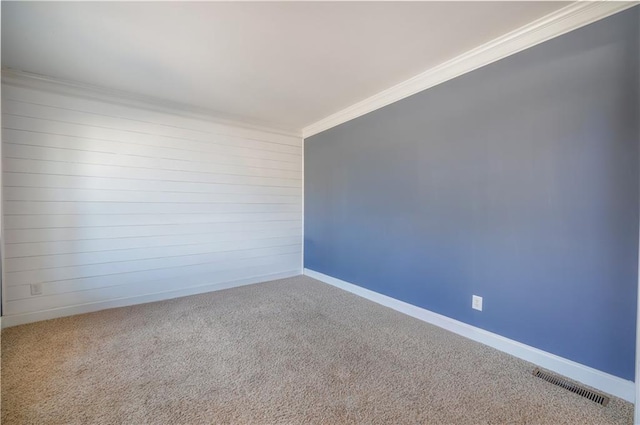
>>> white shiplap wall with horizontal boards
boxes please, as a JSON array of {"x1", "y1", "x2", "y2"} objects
[{"x1": 2, "y1": 80, "x2": 302, "y2": 326}]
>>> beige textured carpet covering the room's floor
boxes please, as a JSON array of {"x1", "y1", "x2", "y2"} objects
[{"x1": 2, "y1": 277, "x2": 632, "y2": 425}]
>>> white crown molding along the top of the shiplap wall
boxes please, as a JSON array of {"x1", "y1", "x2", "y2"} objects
[{"x1": 2, "y1": 68, "x2": 301, "y2": 138}]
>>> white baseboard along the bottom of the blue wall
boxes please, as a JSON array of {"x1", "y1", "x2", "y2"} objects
[{"x1": 304, "y1": 269, "x2": 635, "y2": 403}]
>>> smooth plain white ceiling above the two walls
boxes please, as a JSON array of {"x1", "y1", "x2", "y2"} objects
[{"x1": 2, "y1": 2, "x2": 567, "y2": 131}]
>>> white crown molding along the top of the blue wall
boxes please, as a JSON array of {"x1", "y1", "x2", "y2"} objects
[{"x1": 302, "y1": 1, "x2": 639, "y2": 138}]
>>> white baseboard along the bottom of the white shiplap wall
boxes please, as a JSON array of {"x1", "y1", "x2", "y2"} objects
[{"x1": 0, "y1": 270, "x2": 300, "y2": 329}]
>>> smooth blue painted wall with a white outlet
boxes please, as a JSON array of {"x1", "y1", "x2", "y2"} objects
[{"x1": 304, "y1": 7, "x2": 640, "y2": 380}]
